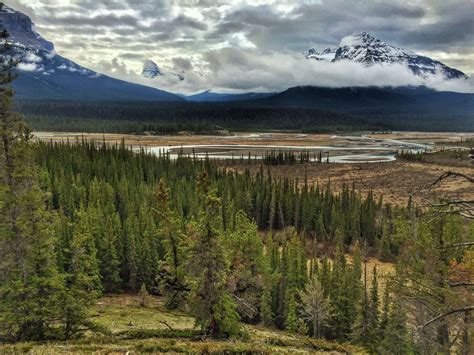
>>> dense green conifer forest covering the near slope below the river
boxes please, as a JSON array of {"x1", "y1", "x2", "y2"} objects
[{"x1": 0, "y1": 31, "x2": 474, "y2": 354}]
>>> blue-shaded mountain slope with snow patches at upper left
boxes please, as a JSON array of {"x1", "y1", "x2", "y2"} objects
[{"x1": 0, "y1": 3, "x2": 182, "y2": 101}]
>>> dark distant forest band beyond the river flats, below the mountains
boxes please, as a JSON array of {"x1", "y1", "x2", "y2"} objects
[{"x1": 16, "y1": 100, "x2": 474, "y2": 134}]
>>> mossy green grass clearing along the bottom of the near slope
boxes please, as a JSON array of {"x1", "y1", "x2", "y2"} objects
[{"x1": 0, "y1": 295, "x2": 364, "y2": 355}]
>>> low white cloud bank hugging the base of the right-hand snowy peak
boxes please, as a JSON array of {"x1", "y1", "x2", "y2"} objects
[{"x1": 96, "y1": 48, "x2": 474, "y2": 93}]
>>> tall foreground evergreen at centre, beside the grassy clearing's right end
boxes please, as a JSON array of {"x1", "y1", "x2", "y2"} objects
[{"x1": 188, "y1": 173, "x2": 241, "y2": 337}]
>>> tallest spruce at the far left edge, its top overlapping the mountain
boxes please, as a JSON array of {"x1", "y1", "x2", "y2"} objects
[{"x1": 0, "y1": 31, "x2": 63, "y2": 340}]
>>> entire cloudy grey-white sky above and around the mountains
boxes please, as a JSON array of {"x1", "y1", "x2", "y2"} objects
[{"x1": 5, "y1": 0, "x2": 474, "y2": 92}]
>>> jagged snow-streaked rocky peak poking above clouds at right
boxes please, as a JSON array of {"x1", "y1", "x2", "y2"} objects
[{"x1": 304, "y1": 32, "x2": 466, "y2": 79}]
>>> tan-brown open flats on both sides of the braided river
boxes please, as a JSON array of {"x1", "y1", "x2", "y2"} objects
[{"x1": 35, "y1": 132, "x2": 474, "y2": 205}]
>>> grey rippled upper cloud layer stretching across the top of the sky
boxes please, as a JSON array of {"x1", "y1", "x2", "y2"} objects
[{"x1": 11, "y1": 0, "x2": 474, "y2": 56}]
